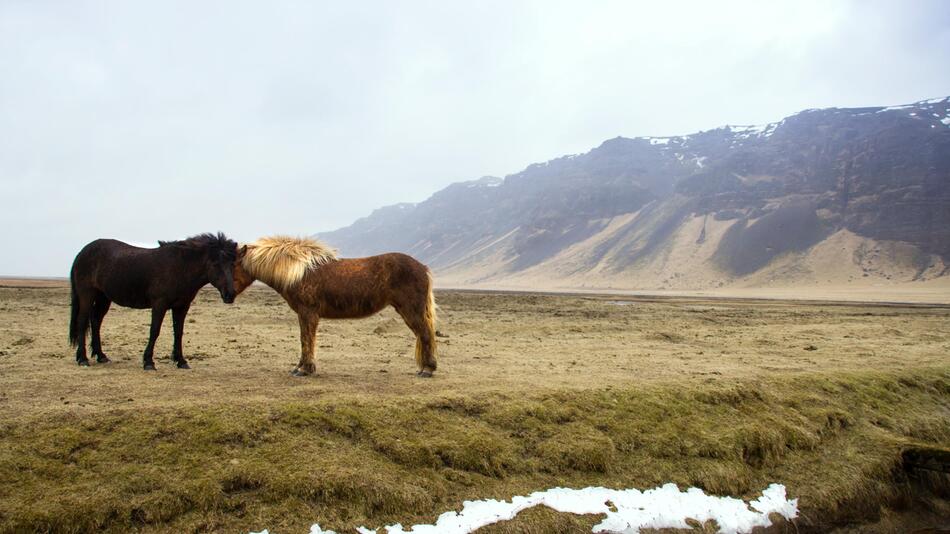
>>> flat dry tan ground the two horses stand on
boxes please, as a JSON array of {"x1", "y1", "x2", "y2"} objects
[{"x1": 0, "y1": 286, "x2": 950, "y2": 414}]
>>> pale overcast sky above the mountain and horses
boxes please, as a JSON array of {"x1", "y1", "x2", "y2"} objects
[{"x1": 0, "y1": 0, "x2": 950, "y2": 276}]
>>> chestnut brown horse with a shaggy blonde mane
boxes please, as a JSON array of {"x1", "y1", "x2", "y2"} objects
[{"x1": 234, "y1": 236, "x2": 436, "y2": 377}]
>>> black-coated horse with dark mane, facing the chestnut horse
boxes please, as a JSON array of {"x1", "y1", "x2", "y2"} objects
[{"x1": 69, "y1": 233, "x2": 237, "y2": 371}]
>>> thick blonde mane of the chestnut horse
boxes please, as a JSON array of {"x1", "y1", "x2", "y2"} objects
[{"x1": 241, "y1": 236, "x2": 337, "y2": 291}]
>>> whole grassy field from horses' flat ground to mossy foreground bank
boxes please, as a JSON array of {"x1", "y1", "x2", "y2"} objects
[{"x1": 0, "y1": 284, "x2": 950, "y2": 533}]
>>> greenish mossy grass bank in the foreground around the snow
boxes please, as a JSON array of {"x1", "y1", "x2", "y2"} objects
[{"x1": 0, "y1": 367, "x2": 950, "y2": 533}]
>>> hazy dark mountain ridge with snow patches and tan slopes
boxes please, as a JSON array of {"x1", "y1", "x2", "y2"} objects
[{"x1": 318, "y1": 97, "x2": 950, "y2": 289}]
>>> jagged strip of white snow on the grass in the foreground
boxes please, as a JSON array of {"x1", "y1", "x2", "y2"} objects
[{"x1": 251, "y1": 484, "x2": 798, "y2": 534}]
